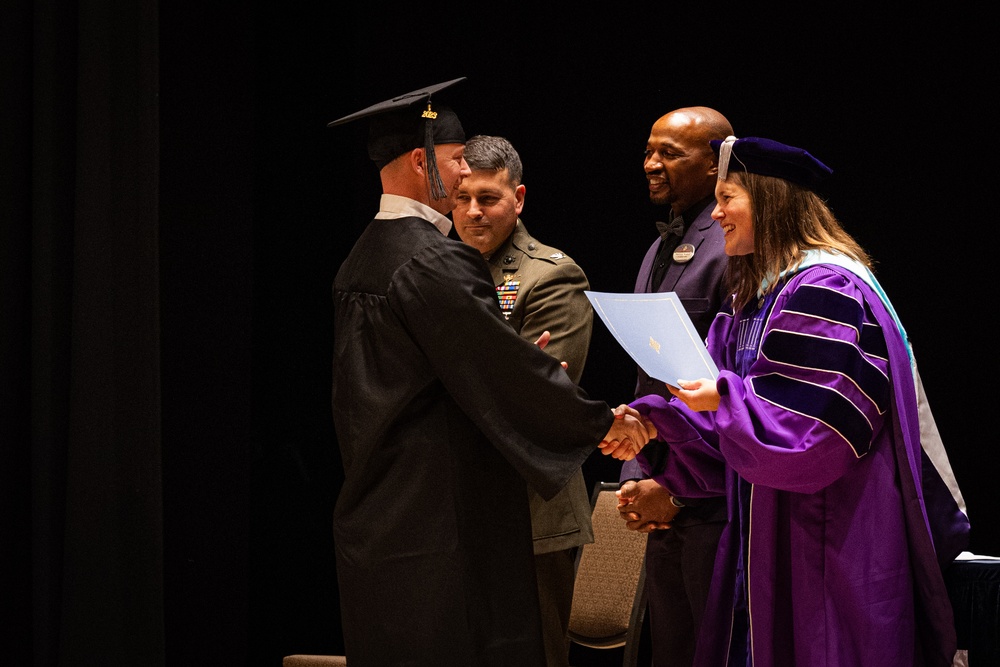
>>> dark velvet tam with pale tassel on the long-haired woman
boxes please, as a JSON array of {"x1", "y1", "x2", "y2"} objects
[{"x1": 709, "y1": 136, "x2": 833, "y2": 190}]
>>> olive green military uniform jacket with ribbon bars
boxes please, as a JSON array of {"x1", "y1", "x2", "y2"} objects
[{"x1": 487, "y1": 219, "x2": 594, "y2": 554}]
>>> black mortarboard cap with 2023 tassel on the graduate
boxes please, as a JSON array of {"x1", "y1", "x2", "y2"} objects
[{"x1": 327, "y1": 76, "x2": 465, "y2": 199}]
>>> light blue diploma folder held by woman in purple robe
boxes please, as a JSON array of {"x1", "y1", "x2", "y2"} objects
[{"x1": 585, "y1": 291, "x2": 719, "y2": 387}]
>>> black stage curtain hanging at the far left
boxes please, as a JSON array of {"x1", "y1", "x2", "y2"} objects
[{"x1": 0, "y1": 0, "x2": 254, "y2": 666}]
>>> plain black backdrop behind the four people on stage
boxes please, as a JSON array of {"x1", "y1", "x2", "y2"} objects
[{"x1": 0, "y1": 0, "x2": 1000, "y2": 667}]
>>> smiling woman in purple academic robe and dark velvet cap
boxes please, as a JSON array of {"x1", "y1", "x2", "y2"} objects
[{"x1": 632, "y1": 137, "x2": 969, "y2": 667}]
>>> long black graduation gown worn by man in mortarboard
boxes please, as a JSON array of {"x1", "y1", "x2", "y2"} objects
[{"x1": 333, "y1": 217, "x2": 612, "y2": 667}]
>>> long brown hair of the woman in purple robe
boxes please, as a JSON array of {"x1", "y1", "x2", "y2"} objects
[{"x1": 726, "y1": 171, "x2": 872, "y2": 312}]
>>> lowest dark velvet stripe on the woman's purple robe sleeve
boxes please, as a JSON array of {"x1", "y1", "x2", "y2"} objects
[{"x1": 752, "y1": 375, "x2": 872, "y2": 456}]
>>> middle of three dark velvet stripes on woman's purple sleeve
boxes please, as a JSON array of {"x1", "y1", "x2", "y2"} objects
[{"x1": 761, "y1": 331, "x2": 889, "y2": 412}]
